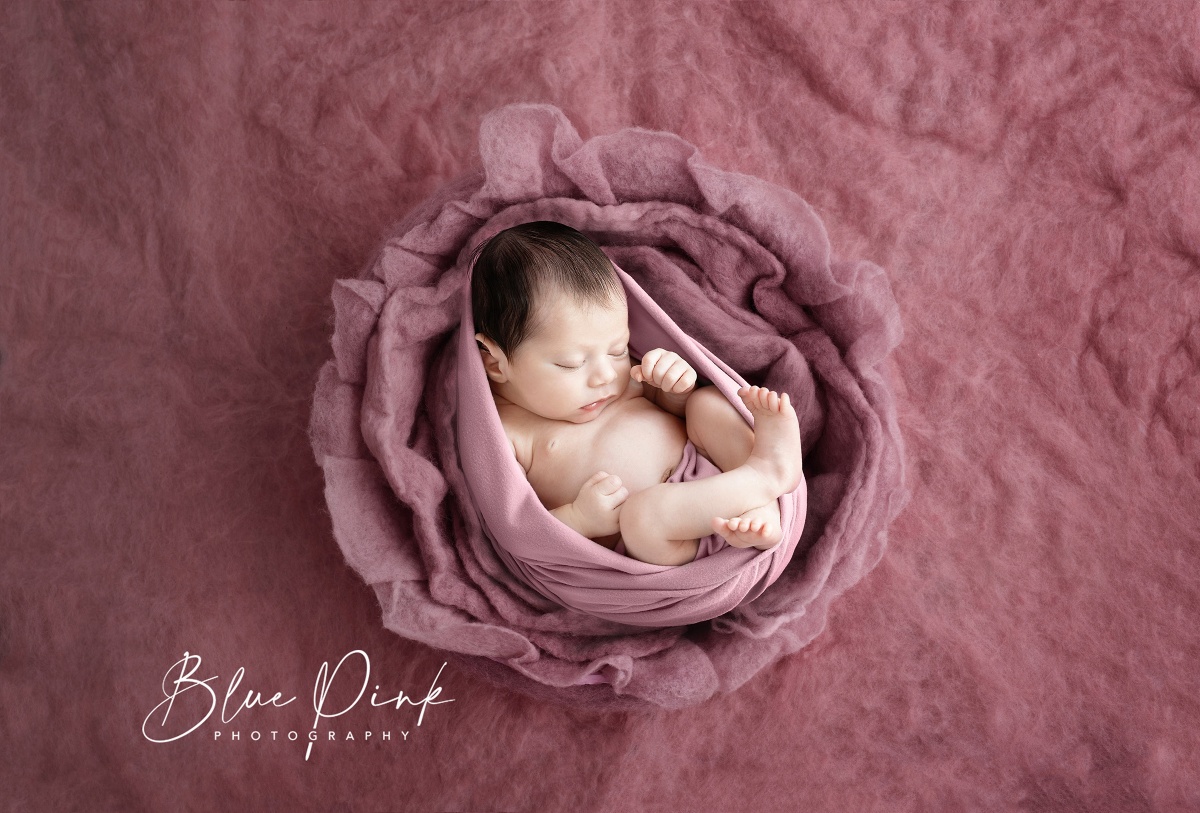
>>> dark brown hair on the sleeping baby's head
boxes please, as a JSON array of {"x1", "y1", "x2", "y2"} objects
[{"x1": 470, "y1": 221, "x2": 624, "y2": 356}]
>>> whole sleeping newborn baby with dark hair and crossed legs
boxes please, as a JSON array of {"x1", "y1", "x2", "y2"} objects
[{"x1": 470, "y1": 222, "x2": 802, "y2": 565}]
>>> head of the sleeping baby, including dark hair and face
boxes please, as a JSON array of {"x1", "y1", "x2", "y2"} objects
[{"x1": 470, "y1": 221, "x2": 630, "y2": 423}]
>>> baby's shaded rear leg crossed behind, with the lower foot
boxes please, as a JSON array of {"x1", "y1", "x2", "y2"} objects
[{"x1": 685, "y1": 386, "x2": 784, "y2": 550}]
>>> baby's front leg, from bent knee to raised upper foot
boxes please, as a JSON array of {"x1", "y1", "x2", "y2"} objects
[{"x1": 620, "y1": 390, "x2": 802, "y2": 565}]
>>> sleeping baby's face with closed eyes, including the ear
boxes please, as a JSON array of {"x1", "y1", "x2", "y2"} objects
[{"x1": 492, "y1": 287, "x2": 630, "y2": 423}]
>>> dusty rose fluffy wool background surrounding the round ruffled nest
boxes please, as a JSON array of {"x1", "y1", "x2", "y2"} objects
[{"x1": 0, "y1": 0, "x2": 1200, "y2": 811}]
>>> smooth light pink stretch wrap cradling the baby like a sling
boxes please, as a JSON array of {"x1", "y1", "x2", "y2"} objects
[{"x1": 457, "y1": 261, "x2": 806, "y2": 627}]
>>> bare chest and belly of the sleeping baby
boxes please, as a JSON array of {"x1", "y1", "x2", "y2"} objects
[{"x1": 528, "y1": 397, "x2": 688, "y2": 508}]
